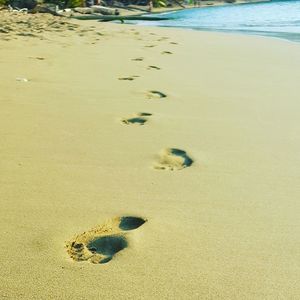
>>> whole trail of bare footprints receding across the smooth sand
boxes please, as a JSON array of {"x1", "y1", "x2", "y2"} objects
[{"x1": 65, "y1": 33, "x2": 194, "y2": 264}]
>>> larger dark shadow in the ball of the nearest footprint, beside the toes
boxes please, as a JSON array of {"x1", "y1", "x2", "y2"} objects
[{"x1": 87, "y1": 235, "x2": 128, "y2": 262}]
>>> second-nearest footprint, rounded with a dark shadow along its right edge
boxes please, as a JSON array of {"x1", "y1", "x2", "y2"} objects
[{"x1": 154, "y1": 148, "x2": 193, "y2": 171}]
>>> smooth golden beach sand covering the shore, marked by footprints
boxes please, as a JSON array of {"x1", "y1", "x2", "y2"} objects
[{"x1": 0, "y1": 12, "x2": 300, "y2": 299}]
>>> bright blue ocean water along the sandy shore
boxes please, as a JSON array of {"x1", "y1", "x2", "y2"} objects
[{"x1": 135, "y1": 0, "x2": 300, "y2": 42}]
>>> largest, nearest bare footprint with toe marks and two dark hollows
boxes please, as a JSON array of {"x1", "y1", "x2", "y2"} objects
[{"x1": 66, "y1": 216, "x2": 147, "y2": 264}]
